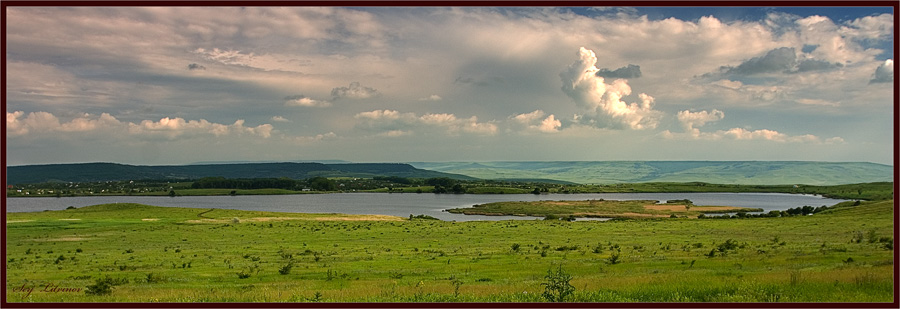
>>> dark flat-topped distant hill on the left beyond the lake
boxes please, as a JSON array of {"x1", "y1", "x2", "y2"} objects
[{"x1": 6, "y1": 163, "x2": 474, "y2": 184}]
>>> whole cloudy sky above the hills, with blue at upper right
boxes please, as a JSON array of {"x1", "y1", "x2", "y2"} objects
[{"x1": 4, "y1": 7, "x2": 895, "y2": 165}]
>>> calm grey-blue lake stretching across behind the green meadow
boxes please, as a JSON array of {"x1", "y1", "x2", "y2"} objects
[{"x1": 6, "y1": 193, "x2": 846, "y2": 221}]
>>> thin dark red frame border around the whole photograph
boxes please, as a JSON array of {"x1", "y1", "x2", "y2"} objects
[{"x1": 0, "y1": 0, "x2": 900, "y2": 308}]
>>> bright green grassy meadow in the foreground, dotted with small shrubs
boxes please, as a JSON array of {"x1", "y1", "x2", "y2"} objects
[{"x1": 6, "y1": 200, "x2": 894, "y2": 302}]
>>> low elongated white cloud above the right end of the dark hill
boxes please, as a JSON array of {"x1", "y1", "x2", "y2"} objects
[{"x1": 354, "y1": 110, "x2": 497, "y2": 137}]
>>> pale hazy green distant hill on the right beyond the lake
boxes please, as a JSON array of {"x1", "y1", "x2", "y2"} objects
[{"x1": 410, "y1": 161, "x2": 894, "y2": 185}]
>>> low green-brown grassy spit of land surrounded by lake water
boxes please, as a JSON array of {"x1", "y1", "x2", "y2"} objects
[{"x1": 447, "y1": 200, "x2": 763, "y2": 219}]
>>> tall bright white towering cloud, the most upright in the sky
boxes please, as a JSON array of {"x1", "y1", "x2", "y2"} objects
[{"x1": 559, "y1": 47, "x2": 662, "y2": 130}]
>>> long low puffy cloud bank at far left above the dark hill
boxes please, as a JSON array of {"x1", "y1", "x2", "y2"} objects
[{"x1": 6, "y1": 111, "x2": 274, "y2": 139}]
